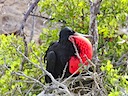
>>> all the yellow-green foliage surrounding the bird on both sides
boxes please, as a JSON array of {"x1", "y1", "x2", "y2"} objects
[{"x1": 0, "y1": 0, "x2": 128, "y2": 96}]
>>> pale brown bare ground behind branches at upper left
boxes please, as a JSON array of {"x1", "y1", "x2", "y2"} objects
[{"x1": 0, "y1": 0, "x2": 46, "y2": 42}]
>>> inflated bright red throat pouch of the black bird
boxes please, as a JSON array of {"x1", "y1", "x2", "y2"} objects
[{"x1": 69, "y1": 35, "x2": 93, "y2": 74}]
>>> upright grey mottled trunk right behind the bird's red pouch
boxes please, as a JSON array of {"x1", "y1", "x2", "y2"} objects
[{"x1": 89, "y1": 0, "x2": 102, "y2": 64}]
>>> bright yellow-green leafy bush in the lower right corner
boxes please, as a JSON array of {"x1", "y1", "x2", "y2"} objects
[{"x1": 101, "y1": 60, "x2": 128, "y2": 96}]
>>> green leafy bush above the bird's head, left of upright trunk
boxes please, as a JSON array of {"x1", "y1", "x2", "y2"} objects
[{"x1": 39, "y1": 0, "x2": 89, "y2": 33}]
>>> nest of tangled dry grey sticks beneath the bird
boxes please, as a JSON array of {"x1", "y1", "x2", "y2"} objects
[{"x1": 38, "y1": 72, "x2": 107, "y2": 96}]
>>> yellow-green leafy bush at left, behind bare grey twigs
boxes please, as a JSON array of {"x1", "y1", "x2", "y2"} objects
[{"x1": 0, "y1": 34, "x2": 44, "y2": 96}]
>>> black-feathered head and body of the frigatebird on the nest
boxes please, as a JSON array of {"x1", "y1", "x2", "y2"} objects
[{"x1": 44, "y1": 27, "x2": 92, "y2": 83}]
